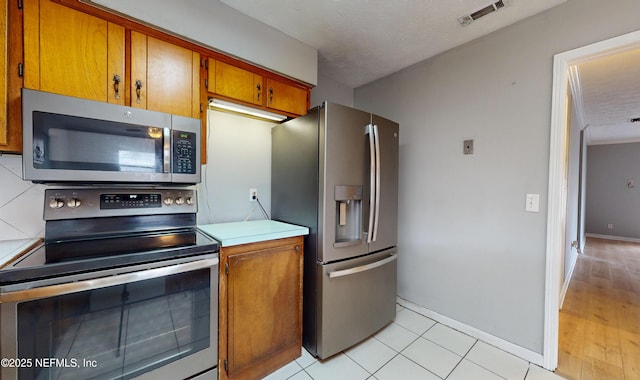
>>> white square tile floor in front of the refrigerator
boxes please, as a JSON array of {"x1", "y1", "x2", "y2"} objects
[{"x1": 264, "y1": 305, "x2": 562, "y2": 380}]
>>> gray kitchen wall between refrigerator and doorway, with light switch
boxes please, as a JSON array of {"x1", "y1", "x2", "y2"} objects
[{"x1": 354, "y1": 0, "x2": 640, "y2": 353}]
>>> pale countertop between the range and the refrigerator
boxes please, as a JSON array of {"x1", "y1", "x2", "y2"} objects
[{"x1": 198, "y1": 220, "x2": 309, "y2": 247}]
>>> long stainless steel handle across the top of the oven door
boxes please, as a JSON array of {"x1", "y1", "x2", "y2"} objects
[{"x1": 0, "y1": 257, "x2": 219, "y2": 303}]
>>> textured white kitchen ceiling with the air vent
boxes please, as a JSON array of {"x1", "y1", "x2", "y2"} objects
[{"x1": 220, "y1": 0, "x2": 566, "y2": 88}]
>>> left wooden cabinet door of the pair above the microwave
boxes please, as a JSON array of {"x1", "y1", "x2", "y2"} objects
[{"x1": 24, "y1": 0, "x2": 125, "y2": 104}]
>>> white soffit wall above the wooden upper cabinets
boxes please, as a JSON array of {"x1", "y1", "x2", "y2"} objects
[{"x1": 93, "y1": 0, "x2": 318, "y2": 85}]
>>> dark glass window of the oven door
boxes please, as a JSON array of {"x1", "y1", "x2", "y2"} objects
[{"x1": 18, "y1": 269, "x2": 210, "y2": 379}]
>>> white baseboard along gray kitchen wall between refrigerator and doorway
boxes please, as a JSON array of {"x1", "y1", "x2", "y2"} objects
[{"x1": 396, "y1": 297, "x2": 543, "y2": 367}]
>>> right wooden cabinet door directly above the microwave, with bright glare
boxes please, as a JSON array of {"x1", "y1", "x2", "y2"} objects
[{"x1": 130, "y1": 31, "x2": 200, "y2": 118}]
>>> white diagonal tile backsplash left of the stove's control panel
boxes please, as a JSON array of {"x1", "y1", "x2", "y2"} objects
[{"x1": 0, "y1": 155, "x2": 46, "y2": 240}]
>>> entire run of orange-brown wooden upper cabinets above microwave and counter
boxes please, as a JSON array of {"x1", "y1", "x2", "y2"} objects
[{"x1": 5, "y1": 0, "x2": 310, "y2": 156}]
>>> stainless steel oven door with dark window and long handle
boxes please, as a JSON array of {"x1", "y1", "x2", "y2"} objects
[{"x1": 0, "y1": 257, "x2": 218, "y2": 379}]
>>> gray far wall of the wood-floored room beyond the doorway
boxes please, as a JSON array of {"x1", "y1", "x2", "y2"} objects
[{"x1": 585, "y1": 143, "x2": 640, "y2": 239}]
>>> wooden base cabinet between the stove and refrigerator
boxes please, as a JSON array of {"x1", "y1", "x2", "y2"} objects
[{"x1": 218, "y1": 236, "x2": 303, "y2": 379}]
